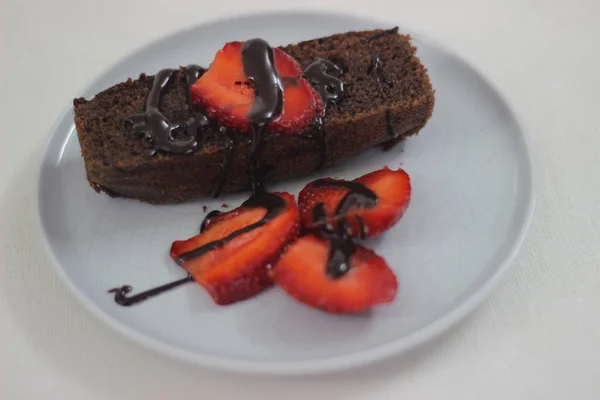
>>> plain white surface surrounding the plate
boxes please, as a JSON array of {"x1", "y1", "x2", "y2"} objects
[{"x1": 0, "y1": 0, "x2": 600, "y2": 400}]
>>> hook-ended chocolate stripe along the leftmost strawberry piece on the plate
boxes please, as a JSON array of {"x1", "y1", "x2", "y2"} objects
[{"x1": 177, "y1": 193, "x2": 285, "y2": 263}]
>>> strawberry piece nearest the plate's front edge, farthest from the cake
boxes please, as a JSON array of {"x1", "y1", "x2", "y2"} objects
[{"x1": 273, "y1": 235, "x2": 398, "y2": 313}]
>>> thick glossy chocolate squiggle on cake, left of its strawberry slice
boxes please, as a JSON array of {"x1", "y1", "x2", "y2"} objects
[{"x1": 124, "y1": 66, "x2": 208, "y2": 155}]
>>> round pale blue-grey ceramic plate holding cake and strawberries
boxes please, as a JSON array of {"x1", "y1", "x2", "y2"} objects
[{"x1": 38, "y1": 13, "x2": 535, "y2": 374}]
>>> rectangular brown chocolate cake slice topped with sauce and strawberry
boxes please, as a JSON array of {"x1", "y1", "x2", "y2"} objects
[{"x1": 74, "y1": 29, "x2": 434, "y2": 203}]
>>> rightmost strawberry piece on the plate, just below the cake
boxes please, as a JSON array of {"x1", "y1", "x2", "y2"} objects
[{"x1": 298, "y1": 167, "x2": 411, "y2": 238}]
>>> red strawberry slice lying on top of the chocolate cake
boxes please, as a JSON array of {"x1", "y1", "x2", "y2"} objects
[{"x1": 191, "y1": 42, "x2": 324, "y2": 134}]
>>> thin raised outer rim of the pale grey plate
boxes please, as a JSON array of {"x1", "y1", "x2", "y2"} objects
[{"x1": 34, "y1": 10, "x2": 539, "y2": 376}]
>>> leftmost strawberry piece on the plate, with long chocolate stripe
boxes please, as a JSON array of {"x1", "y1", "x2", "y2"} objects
[{"x1": 170, "y1": 193, "x2": 300, "y2": 305}]
